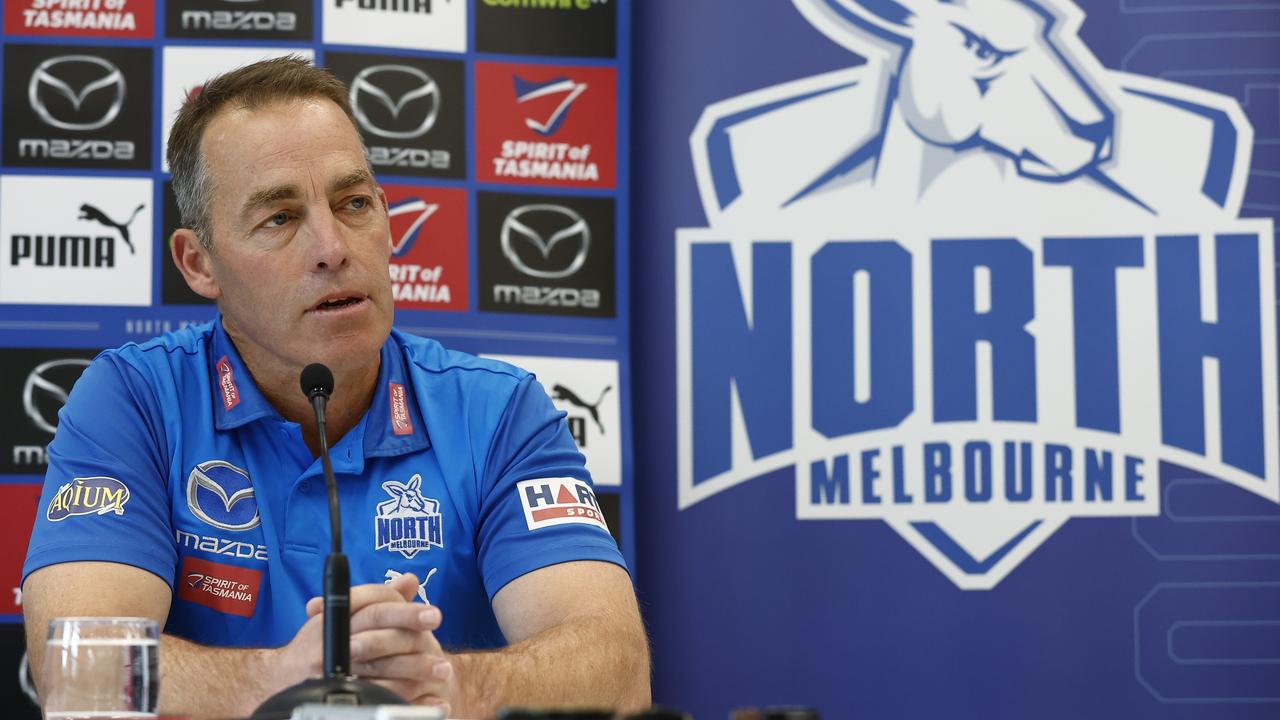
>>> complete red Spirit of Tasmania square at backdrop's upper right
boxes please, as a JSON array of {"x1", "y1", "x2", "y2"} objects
[{"x1": 475, "y1": 63, "x2": 617, "y2": 187}]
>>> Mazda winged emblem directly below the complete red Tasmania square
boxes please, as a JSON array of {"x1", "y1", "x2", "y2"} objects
[{"x1": 502, "y1": 205, "x2": 591, "y2": 279}]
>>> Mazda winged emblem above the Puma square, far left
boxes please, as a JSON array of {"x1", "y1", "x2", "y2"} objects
[{"x1": 27, "y1": 55, "x2": 124, "y2": 131}]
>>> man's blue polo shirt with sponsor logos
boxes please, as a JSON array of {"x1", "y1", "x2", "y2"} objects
[{"x1": 23, "y1": 318, "x2": 625, "y2": 648}]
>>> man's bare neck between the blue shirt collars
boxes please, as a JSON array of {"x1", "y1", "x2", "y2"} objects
[{"x1": 223, "y1": 320, "x2": 381, "y2": 456}]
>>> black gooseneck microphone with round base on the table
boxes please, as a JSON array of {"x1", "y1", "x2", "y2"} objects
[{"x1": 253, "y1": 363, "x2": 406, "y2": 720}]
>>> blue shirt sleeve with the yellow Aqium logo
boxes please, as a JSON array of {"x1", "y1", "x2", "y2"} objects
[{"x1": 22, "y1": 352, "x2": 177, "y2": 587}]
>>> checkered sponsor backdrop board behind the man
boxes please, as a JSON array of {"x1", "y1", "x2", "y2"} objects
[{"x1": 0, "y1": 0, "x2": 635, "y2": 707}]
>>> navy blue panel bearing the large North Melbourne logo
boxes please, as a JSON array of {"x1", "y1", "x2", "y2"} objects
[{"x1": 631, "y1": 0, "x2": 1280, "y2": 719}]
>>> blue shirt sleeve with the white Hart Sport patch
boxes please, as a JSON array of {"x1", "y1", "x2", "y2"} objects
[{"x1": 477, "y1": 375, "x2": 626, "y2": 600}]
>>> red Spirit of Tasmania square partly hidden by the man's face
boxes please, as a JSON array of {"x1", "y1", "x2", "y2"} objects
[{"x1": 383, "y1": 184, "x2": 468, "y2": 310}]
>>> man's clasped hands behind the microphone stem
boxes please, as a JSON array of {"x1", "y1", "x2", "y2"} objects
[{"x1": 283, "y1": 573, "x2": 453, "y2": 715}]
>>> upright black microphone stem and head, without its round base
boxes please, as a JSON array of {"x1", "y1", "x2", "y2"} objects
[{"x1": 300, "y1": 363, "x2": 351, "y2": 678}]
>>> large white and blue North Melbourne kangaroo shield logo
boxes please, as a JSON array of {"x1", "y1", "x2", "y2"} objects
[{"x1": 676, "y1": 0, "x2": 1280, "y2": 589}]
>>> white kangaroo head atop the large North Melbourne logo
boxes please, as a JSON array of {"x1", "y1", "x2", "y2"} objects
[{"x1": 795, "y1": 0, "x2": 1114, "y2": 181}]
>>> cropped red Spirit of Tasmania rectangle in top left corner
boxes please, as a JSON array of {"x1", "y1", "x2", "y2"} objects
[{"x1": 4, "y1": 0, "x2": 155, "y2": 38}]
